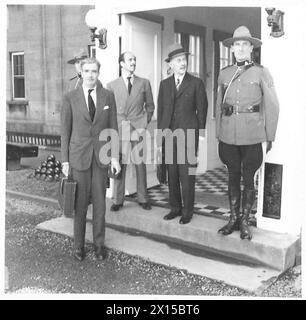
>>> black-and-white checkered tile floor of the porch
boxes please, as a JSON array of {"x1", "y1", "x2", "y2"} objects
[{"x1": 126, "y1": 167, "x2": 256, "y2": 225}]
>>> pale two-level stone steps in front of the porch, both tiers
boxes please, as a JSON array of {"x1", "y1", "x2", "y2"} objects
[{"x1": 37, "y1": 195, "x2": 298, "y2": 294}]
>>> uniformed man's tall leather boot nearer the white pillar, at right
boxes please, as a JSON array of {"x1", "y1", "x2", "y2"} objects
[{"x1": 240, "y1": 189, "x2": 255, "y2": 240}]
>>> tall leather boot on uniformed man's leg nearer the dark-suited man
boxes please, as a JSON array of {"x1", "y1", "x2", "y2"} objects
[{"x1": 218, "y1": 188, "x2": 241, "y2": 236}]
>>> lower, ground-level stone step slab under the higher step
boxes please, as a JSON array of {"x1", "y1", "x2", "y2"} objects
[{"x1": 37, "y1": 214, "x2": 281, "y2": 295}]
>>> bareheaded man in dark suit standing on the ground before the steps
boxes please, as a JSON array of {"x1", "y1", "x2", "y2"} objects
[{"x1": 61, "y1": 58, "x2": 120, "y2": 261}]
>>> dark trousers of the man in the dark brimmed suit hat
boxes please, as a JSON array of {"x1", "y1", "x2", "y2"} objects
[{"x1": 167, "y1": 139, "x2": 195, "y2": 218}]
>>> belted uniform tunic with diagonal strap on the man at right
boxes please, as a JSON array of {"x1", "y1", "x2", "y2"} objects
[{"x1": 216, "y1": 63, "x2": 279, "y2": 145}]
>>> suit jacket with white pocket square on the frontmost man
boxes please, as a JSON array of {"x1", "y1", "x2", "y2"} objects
[{"x1": 61, "y1": 83, "x2": 118, "y2": 170}]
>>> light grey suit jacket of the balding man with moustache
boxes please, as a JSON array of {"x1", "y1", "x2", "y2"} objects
[{"x1": 107, "y1": 75, "x2": 154, "y2": 138}]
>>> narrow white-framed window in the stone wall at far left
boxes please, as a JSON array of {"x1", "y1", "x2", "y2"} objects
[{"x1": 12, "y1": 52, "x2": 25, "y2": 99}]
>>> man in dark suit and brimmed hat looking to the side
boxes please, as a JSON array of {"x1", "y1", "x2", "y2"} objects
[{"x1": 157, "y1": 44, "x2": 208, "y2": 224}]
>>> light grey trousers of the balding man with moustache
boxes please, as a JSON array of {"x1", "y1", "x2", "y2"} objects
[{"x1": 113, "y1": 141, "x2": 148, "y2": 204}]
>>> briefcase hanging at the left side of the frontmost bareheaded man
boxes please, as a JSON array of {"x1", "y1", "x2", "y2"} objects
[{"x1": 58, "y1": 176, "x2": 77, "y2": 218}]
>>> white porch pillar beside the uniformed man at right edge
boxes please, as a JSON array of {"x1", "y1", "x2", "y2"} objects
[{"x1": 257, "y1": 3, "x2": 306, "y2": 234}]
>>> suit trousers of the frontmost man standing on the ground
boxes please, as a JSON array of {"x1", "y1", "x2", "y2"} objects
[{"x1": 71, "y1": 156, "x2": 107, "y2": 249}]
